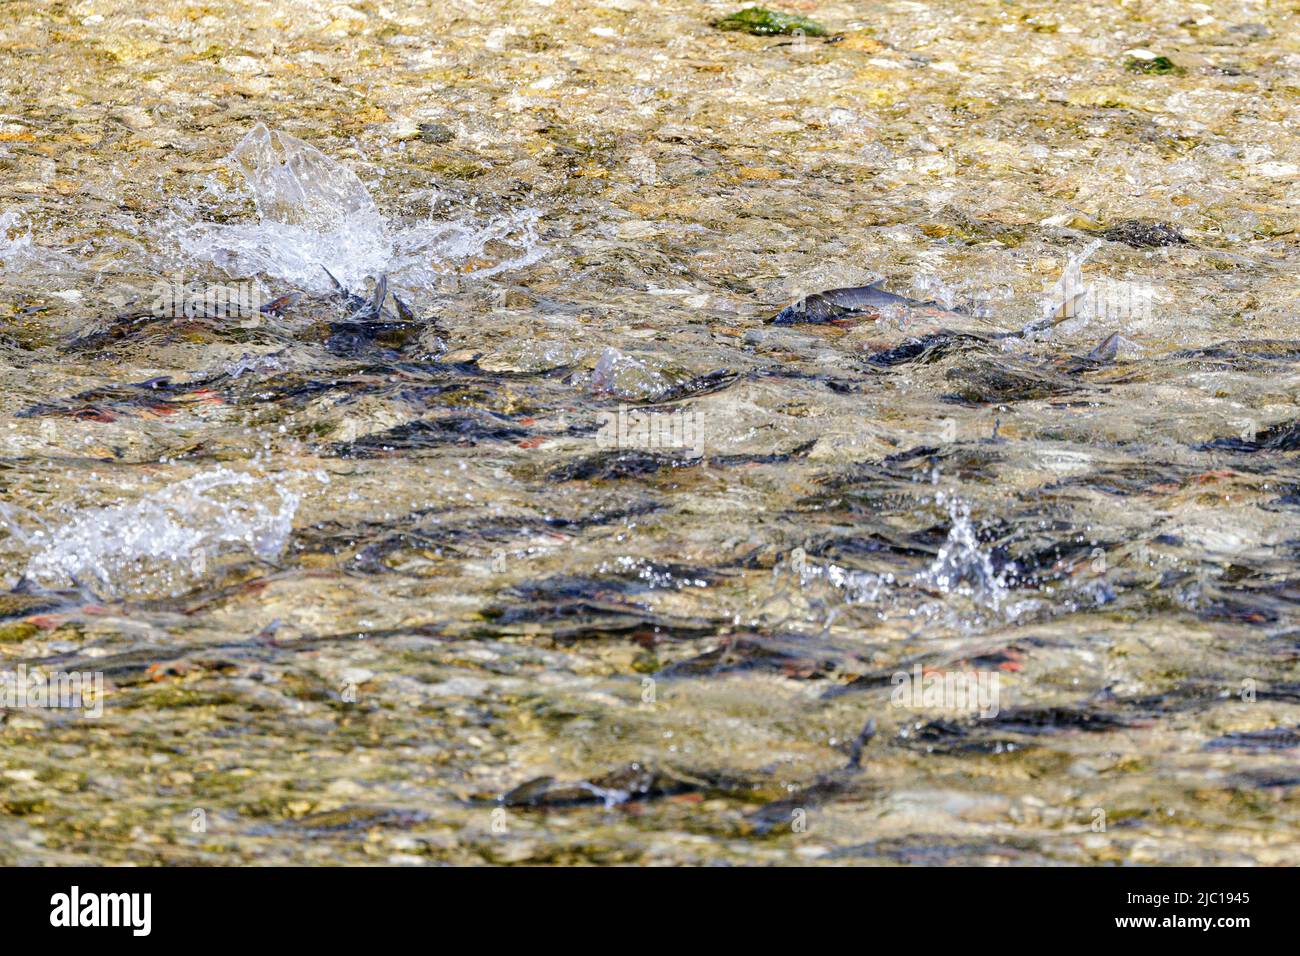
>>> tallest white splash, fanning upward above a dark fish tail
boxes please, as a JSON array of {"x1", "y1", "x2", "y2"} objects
[{"x1": 178, "y1": 124, "x2": 541, "y2": 291}]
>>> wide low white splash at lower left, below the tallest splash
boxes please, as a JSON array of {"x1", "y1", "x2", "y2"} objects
[{"x1": 25, "y1": 468, "x2": 300, "y2": 594}]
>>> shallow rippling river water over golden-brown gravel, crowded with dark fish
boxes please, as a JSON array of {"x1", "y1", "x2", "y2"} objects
[{"x1": 0, "y1": 0, "x2": 1300, "y2": 865}]
